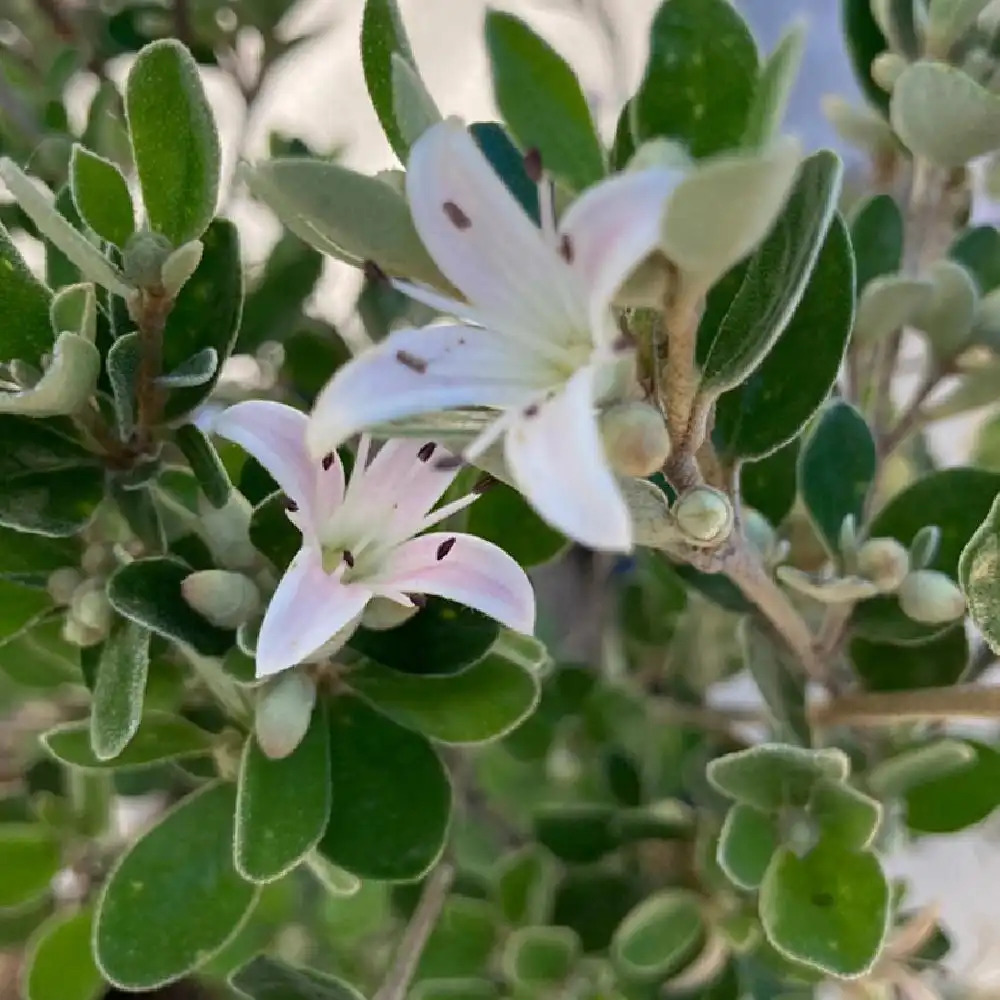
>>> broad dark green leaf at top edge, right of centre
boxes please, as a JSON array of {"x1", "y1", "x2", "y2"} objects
[{"x1": 631, "y1": 0, "x2": 757, "y2": 157}]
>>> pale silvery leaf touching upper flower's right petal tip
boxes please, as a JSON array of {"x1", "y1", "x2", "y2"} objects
[{"x1": 660, "y1": 138, "x2": 801, "y2": 288}]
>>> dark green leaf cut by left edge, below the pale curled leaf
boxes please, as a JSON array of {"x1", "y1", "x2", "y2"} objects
[{"x1": 0, "y1": 416, "x2": 104, "y2": 536}]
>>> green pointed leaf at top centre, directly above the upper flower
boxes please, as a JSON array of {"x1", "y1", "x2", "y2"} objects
[{"x1": 486, "y1": 10, "x2": 604, "y2": 191}]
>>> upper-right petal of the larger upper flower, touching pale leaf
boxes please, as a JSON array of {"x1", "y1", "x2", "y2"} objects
[{"x1": 559, "y1": 167, "x2": 684, "y2": 348}]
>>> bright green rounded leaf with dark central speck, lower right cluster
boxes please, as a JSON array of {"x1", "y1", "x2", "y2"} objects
[{"x1": 760, "y1": 841, "x2": 891, "y2": 977}]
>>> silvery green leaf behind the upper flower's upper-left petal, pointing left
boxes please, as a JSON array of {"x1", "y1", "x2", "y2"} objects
[{"x1": 244, "y1": 157, "x2": 448, "y2": 288}]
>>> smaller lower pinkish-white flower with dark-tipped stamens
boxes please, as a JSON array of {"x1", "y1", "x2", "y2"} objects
[{"x1": 213, "y1": 400, "x2": 535, "y2": 677}]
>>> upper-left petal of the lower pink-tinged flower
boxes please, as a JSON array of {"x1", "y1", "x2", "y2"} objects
[{"x1": 212, "y1": 400, "x2": 344, "y2": 524}]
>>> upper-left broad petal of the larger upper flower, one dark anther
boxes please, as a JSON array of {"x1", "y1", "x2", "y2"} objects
[{"x1": 406, "y1": 120, "x2": 586, "y2": 340}]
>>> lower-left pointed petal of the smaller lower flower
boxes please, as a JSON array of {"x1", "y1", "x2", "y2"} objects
[{"x1": 257, "y1": 546, "x2": 372, "y2": 677}]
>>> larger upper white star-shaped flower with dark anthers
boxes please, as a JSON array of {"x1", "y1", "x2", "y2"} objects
[{"x1": 308, "y1": 120, "x2": 683, "y2": 551}]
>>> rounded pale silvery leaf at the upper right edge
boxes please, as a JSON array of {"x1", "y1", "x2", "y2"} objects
[{"x1": 890, "y1": 60, "x2": 1000, "y2": 167}]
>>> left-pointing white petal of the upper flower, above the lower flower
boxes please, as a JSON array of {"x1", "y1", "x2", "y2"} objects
[{"x1": 306, "y1": 325, "x2": 555, "y2": 457}]
